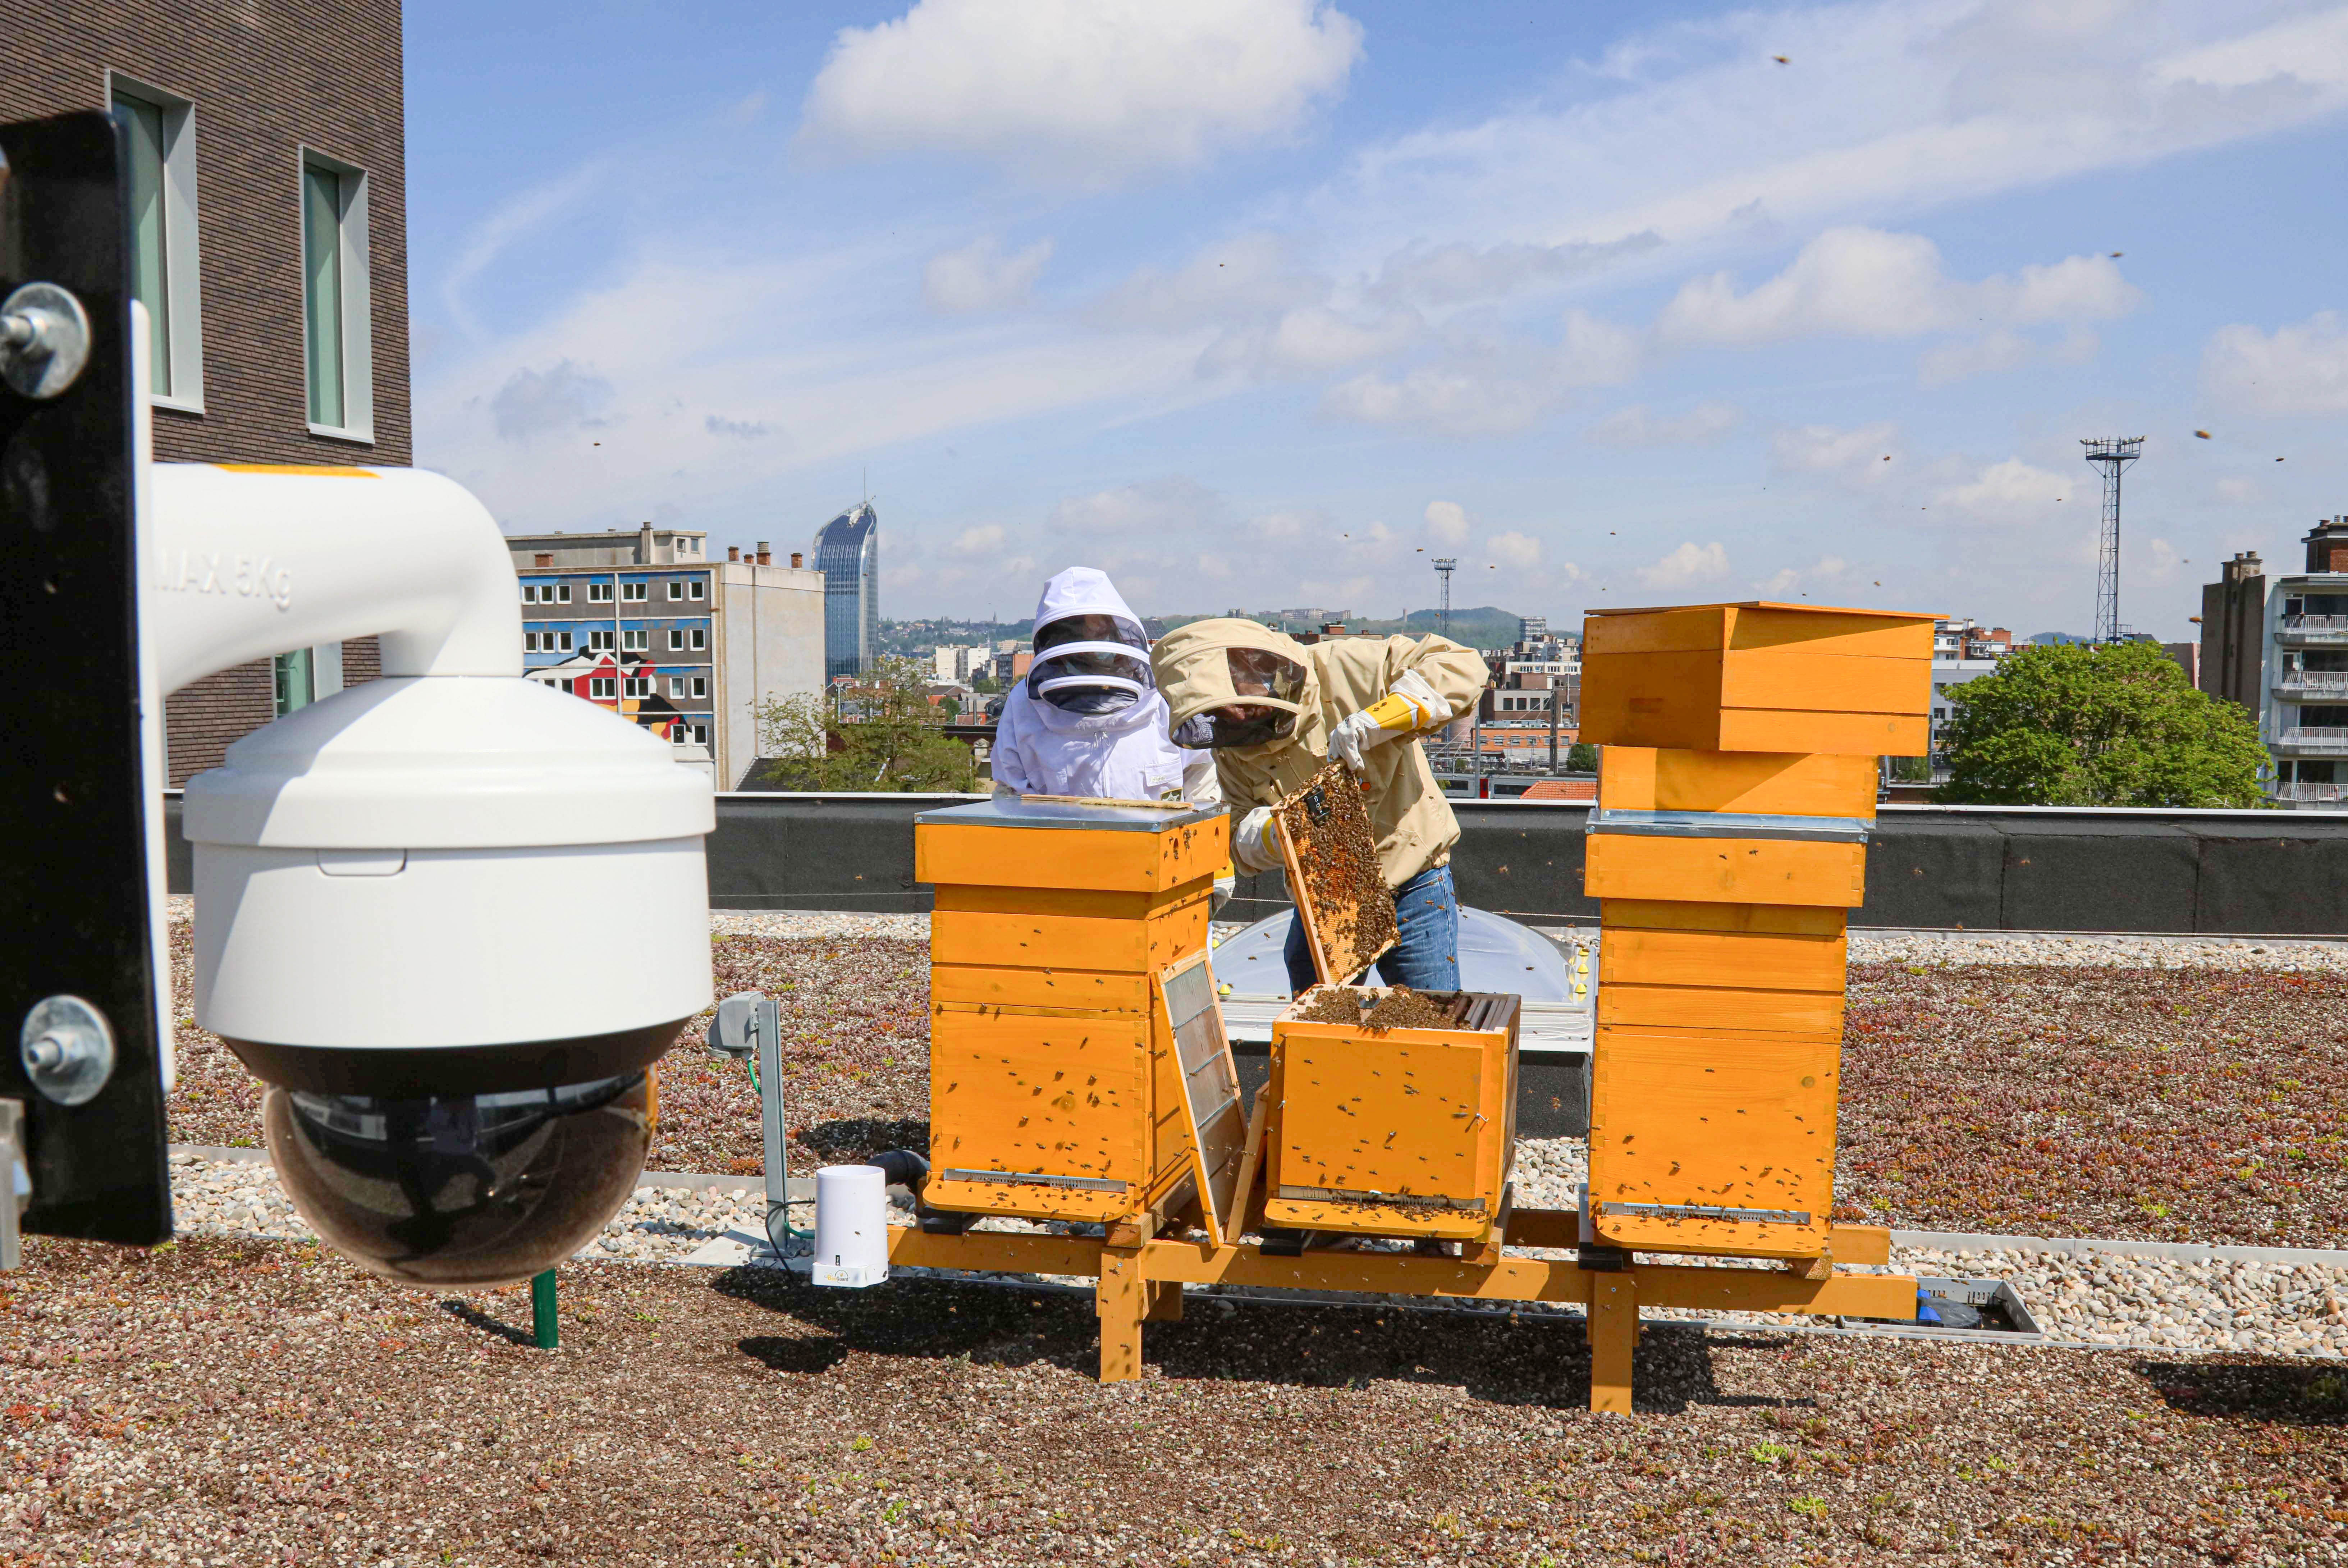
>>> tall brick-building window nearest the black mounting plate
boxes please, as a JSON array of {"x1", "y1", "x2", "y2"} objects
[{"x1": 108, "y1": 75, "x2": 204, "y2": 413}]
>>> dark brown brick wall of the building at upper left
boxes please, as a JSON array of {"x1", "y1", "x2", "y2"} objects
[{"x1": 0, "y1": 0, "x2": 411, "y2": 786}]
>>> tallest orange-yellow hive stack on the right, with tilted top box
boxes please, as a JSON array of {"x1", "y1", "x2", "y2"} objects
[{"x1": 1580, "y1": 603, "x2": 1932, "y2": 1258}]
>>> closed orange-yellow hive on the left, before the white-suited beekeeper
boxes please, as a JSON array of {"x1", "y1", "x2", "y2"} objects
[{"x1": 914, "y1": 798, "x2": 1230, "y2": 1223}]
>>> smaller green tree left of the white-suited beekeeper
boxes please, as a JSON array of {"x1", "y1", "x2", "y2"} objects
[{"x1": 756, "y1": 657, "x2": 979, "y2": 794}]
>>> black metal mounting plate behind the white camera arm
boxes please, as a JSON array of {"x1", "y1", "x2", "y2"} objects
[{"x1": 0, "y1": 113, "x2": 171, "y2": 1244}]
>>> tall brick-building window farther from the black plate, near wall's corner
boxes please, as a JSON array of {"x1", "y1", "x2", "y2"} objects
[{"x1": 301, "y1": 148, "x2": 376, "y2": 441}]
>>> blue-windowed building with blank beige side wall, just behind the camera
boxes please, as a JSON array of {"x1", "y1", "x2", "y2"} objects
[{"x1": 507, "y1": 524, "x2": 824, "y2": 789}]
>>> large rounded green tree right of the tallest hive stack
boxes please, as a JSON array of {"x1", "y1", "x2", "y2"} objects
[{"x1": 1940, "y1": 643, "x2": 2266, "y2": 805}]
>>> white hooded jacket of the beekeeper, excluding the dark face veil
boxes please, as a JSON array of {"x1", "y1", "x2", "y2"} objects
[{"x1": 993, "y1": 566, "x2": 1223, "y2": 803}]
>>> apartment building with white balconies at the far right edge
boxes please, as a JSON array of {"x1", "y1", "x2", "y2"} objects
[{"x1": 2198, "y1": 516, "x2": 2348, "y2": 808}]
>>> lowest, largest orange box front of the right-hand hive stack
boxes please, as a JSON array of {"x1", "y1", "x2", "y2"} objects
[{"x1": 1589, "y1": 1026, "x2": 1841, "y2": 1258}]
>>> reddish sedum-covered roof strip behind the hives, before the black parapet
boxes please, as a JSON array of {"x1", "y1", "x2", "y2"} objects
[{"x1": 171, "y1": 918, "x2": 2348, "y2": 1247}]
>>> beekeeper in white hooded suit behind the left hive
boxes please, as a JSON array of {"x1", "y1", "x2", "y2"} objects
[{"x1": 993, "y1": 566, "x2": 1223, "y2": 803}]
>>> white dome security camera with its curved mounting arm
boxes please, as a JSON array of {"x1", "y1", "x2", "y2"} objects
[{"x1": 138, "y1": 446, "x2": 714, "y2": 1286}]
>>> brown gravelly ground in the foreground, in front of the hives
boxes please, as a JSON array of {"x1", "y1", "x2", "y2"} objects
[{"x1": 0, "y1": 1239, "x2": 2348, "y2": 1568}]
